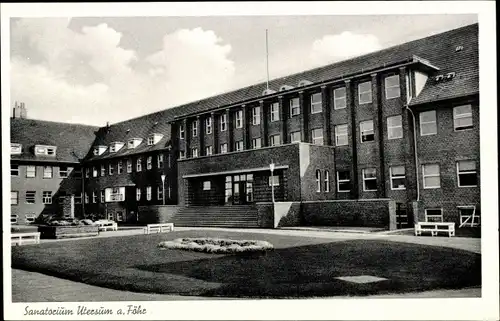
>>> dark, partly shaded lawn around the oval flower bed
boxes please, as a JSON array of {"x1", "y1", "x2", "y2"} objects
[{"x1": 12, "y1": 231, "x2": 481, "y2": 298}]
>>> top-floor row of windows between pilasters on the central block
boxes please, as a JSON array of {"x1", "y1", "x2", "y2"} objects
[{"x1": 179, "y1": 75, "x2": 401, "y2": 139}]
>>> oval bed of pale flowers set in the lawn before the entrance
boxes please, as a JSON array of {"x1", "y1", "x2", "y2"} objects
[{"x1": 158, "y1": 238, "x2": 273, "y2": 254}]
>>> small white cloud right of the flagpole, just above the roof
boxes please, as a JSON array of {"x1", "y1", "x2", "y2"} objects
[{"x1": 310, "y1": 31, "x2": 382, "y2": 65}]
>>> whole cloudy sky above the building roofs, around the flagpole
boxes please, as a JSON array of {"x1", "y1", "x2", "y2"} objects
[{"x1": 10, "y1": 14, "x2": 477, "y2": 126}]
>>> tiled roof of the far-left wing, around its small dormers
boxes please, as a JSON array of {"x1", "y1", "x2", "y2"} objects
[{"x1": 10, "y1": 118, "x2": 99, "y2": 163}]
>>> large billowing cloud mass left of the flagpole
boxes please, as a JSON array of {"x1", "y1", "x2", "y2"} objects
[{"x1": 11, "y1": 18, "x2": 235, "y2": 125}]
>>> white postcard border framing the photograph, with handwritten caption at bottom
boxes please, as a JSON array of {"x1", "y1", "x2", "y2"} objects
[{"x1": 1, "y1": 1, "x2": 499, "y2": 320}]
